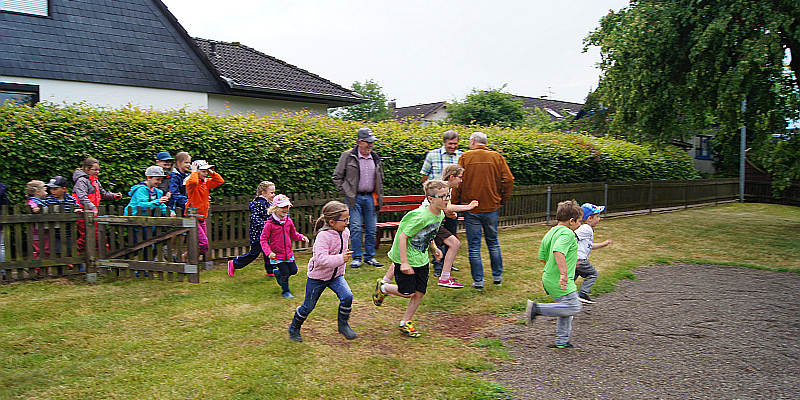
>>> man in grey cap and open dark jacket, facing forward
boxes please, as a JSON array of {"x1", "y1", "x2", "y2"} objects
[{"x1": 332, "y1": 128, "x2": 383, "y2": 268}]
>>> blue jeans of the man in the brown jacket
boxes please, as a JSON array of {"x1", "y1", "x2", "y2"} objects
[{"x1": 464, "y1": 210, "x2": 503, "y2": 282}]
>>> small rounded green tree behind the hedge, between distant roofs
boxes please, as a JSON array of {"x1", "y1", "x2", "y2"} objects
[{"x1": 447, "y1": 86, "x2": 526, "y2": 127}]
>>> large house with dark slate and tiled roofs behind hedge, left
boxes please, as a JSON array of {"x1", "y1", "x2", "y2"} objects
[{"x1": 0, "y1": 0, "x2": 365, "y2": 115}]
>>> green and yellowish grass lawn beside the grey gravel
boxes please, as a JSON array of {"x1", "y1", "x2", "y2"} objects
[{"x1": 0, "y1": 204, "x2": 800, "y2": 400}]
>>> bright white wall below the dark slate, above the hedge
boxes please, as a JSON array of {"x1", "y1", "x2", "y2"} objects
[{"x1": 0, "y1": 75, "x2": 207, "y2": 111}]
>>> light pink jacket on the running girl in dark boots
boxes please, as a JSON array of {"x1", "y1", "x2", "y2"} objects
[{"x1": 308, "y1": 225, "x2": 350, "y2": 281}]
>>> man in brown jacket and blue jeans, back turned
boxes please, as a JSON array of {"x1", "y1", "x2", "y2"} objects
[{"x1": 451, "y1": 132, "x2": 514, "y2": 289}]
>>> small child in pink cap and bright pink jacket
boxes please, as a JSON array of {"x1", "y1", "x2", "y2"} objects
[{"x1": 260, "y1": 194, "x2": 308, "y2": 299}]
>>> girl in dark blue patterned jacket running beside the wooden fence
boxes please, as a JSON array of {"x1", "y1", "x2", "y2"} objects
[{"x1": 228, "y1": 181, "x2": 275, "y2": 276}]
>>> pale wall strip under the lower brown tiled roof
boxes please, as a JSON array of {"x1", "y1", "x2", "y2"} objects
[{"x1": 208, "y1": 94, "x2": 328, "y2": 117}]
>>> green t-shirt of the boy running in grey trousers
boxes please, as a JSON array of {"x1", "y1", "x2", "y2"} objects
[{"x1": 539, "y1": 225, "x2": 578, "y2": 297}]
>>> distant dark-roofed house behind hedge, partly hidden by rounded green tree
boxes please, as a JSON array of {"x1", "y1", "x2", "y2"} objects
[{"x1": 389, "y1": 95, "x2": 583, "y2": 126}]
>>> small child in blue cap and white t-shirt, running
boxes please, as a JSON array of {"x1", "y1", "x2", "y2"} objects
[{"x1": 574, "y1": 203, "x2": 614, "y2": 304}]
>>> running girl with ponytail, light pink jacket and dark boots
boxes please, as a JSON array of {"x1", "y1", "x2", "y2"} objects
[{"x1": 289, "y1": 201, "x2": 358, "y2": 342}]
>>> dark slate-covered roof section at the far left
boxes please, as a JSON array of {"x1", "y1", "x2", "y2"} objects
[{"x1": 0, "y1": 0, "x2": 225, "y2": 92}]
